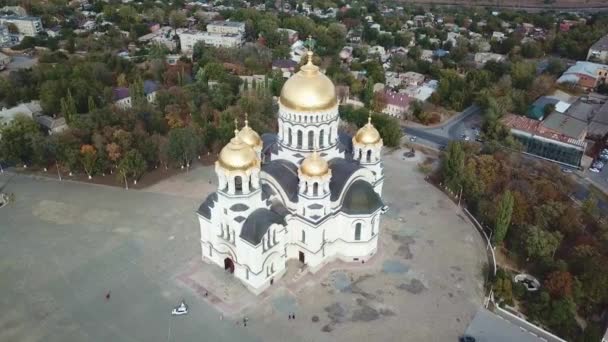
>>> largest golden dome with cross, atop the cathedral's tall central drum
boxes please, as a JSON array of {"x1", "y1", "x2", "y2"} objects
[{"x1": 279, "y1": 51, "x2": 338, "y2": 112}]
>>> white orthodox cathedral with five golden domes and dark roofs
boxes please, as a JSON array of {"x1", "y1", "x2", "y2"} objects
[{"x1": 197, "y1": 52, "x2": 386, "y2": 294}]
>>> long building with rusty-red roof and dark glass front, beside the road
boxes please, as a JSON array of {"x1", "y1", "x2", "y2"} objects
[{"x1": 501, "y1": 114, "x2": 587, "y2": 167}]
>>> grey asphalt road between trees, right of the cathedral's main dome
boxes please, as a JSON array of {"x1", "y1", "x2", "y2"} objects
[{"x1": 403, "y1": 105, "x2": 481, "y2": 148}]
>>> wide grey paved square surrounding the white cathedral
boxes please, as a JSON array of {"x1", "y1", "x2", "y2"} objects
[{"x1": 0, "y1": 151, "x2": 485, "y2": 342}]
